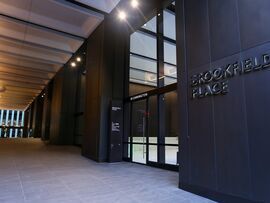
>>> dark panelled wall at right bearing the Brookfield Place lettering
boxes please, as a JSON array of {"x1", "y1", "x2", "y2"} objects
[{"x1": 176, "y1": 0, "x2": 270, "y2": 202}]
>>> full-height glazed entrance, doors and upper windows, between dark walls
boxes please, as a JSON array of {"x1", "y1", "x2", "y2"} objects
[{"x1": 123, "y1": 0, "x2": 179, "y2": 170}]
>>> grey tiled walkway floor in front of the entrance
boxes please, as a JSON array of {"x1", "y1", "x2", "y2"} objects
[{"x1": 0, "y1": 139, "x2": 215, "y2": 203}]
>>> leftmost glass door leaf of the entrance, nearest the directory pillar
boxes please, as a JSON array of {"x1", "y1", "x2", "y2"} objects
[{"x1": 131, "y1": 99, "x2": 147, "y2": 164}]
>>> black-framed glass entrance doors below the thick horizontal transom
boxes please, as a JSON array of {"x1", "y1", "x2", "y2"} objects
[{"x1": 123, "y1": 85, "x2": 179, "y2": 171}]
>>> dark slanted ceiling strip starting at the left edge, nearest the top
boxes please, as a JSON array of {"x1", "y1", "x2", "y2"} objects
[{"x1": 0, "y1": 14, "x2": 85, "y2": 41}]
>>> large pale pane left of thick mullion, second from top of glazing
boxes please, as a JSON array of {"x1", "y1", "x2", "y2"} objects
[{"x1": 130, "y1": 32, "x2": 157, "y2": 59}]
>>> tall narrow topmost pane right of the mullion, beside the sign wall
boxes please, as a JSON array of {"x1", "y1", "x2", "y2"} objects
[{"x1": 163, "y1": 10, "x2": 176, "y2": 40}]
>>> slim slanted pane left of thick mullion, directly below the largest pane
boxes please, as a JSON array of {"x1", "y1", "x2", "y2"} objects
[{"x1": 130, "y1": 54, "x2": 157, "y2": 73}]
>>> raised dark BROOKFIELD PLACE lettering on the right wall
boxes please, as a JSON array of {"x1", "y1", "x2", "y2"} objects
[{"x1": 190, "y1": 54, "x2": 270, "y2": 99}]
